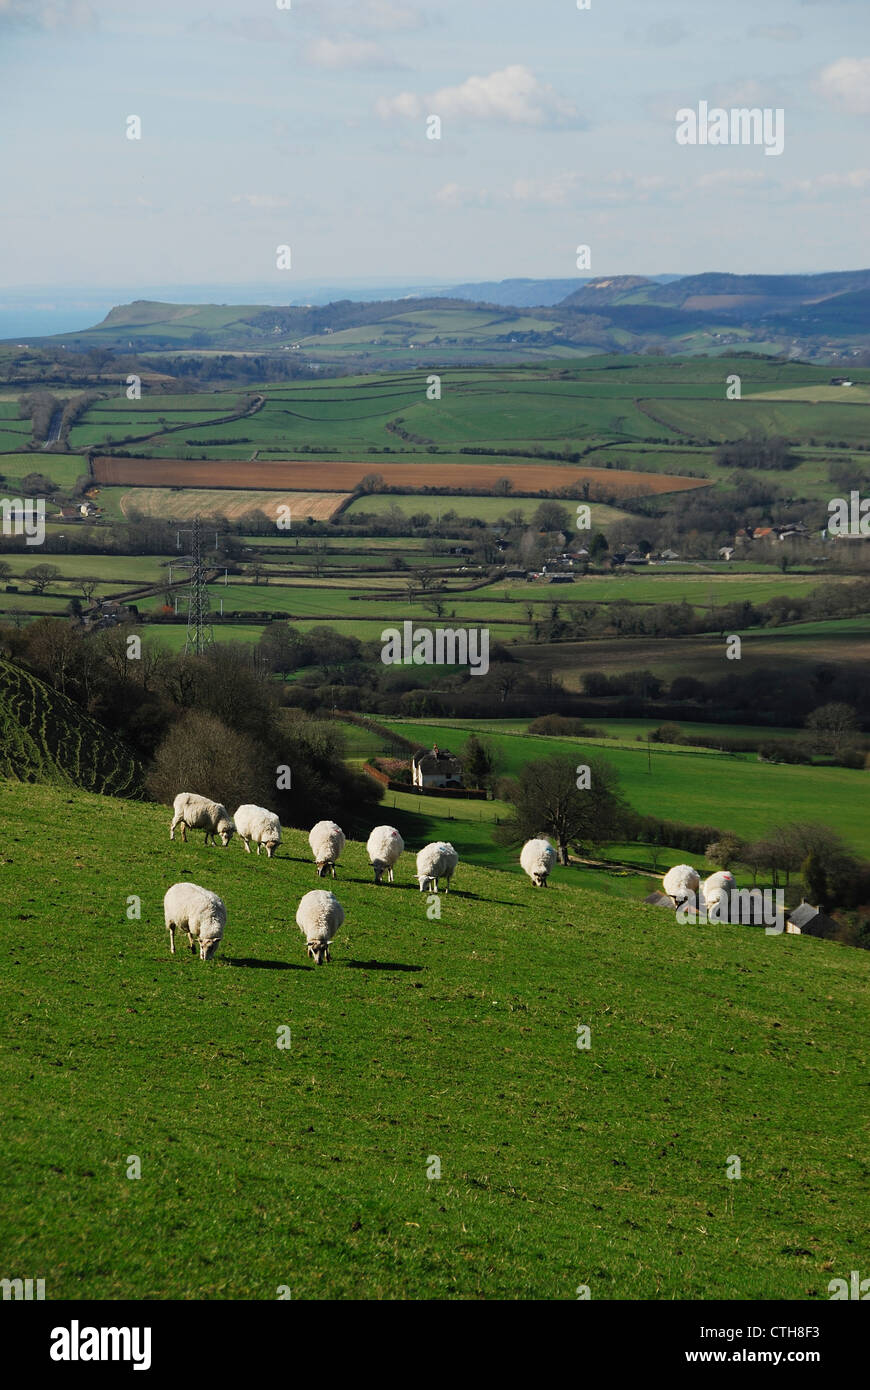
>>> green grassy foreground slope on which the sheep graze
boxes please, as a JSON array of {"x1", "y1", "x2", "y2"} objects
[{"x1": 0, "y1": 783, "x2": 866, "y2": 1300}]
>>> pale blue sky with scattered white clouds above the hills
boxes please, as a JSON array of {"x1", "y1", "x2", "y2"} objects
[{"x1": 0, "y1": 0, "x2": 870, "y2": 293}]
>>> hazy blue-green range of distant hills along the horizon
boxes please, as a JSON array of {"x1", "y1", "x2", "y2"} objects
[{"x1": 23, "y1": 270, "x2": 870, "y2": 374}]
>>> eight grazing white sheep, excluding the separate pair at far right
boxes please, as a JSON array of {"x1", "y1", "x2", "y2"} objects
[{"x1": 163, "y1": 791, "x2": 556, "y2": 965}]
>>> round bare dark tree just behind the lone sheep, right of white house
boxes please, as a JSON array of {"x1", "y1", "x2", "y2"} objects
[{"x1": 496, "y1": 758, "x2": 627, "y2": 865}]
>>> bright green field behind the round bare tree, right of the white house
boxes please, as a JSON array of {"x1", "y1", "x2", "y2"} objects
[{"x1": 381, "y1": 717, "x2": 870, "y2": 852}]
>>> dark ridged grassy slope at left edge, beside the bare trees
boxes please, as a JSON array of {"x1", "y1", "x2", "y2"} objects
[{"x1": 0, "y1": 660, "x2": 142, "y2": 796}]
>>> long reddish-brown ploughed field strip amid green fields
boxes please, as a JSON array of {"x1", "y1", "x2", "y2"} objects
[{"x1": 93, "y1": 455, "x2": 709, "y2": 498}]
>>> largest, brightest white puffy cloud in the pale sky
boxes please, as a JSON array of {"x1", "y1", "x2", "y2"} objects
[{"x1": 375, "y1": 64, "x2": 575, "y2": 129}]
